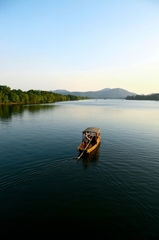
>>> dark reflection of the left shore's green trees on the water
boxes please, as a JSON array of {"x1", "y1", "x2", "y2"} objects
[{"x1": 0, "y1": 105, "x2": 55, "y2": 120}]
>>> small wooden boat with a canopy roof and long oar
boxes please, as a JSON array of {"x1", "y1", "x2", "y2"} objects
[{"x1": 77, "y1": 127, "x2": 101, "y2": 159}]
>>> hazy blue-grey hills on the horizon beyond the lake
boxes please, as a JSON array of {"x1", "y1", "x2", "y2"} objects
[{"x1": 53, "y1": 88, "x2": 136, "y2": 99}]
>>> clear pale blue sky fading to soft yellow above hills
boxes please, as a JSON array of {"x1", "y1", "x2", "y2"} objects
[{"x1": 0, "y1": 0, "x2": 159, "y2": 94}]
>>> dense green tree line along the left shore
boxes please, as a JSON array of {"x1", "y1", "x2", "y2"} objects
[{"x1": 0, "y1": 85, "x2": 88, "y2": 104}]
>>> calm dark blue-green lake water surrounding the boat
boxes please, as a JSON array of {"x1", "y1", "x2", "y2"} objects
[{"x1": 0, "y1": 100, "x2": 159, "y2": 239}]
